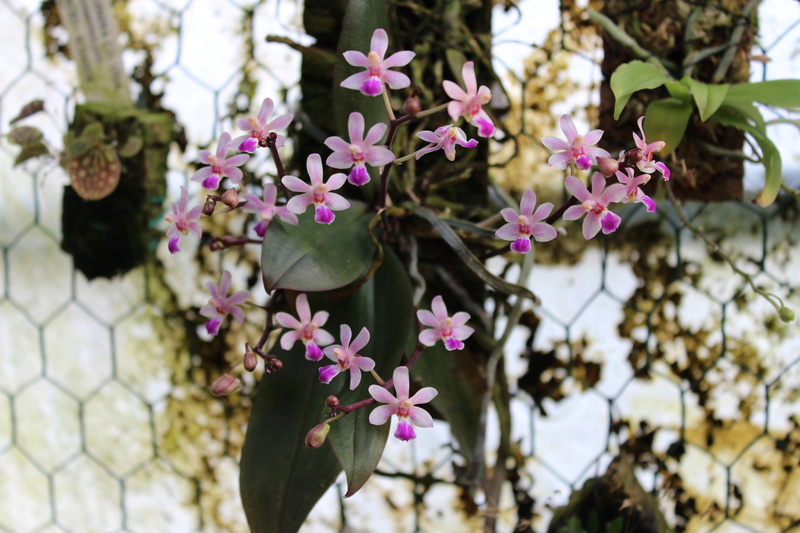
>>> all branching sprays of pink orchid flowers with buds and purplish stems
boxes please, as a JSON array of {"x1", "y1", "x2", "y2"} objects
[{"x1": 167, "y1": 29, "x2": 669, "y2": 458}]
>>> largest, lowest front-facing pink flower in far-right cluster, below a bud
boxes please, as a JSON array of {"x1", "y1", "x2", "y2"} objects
[{"x1": 564, "y1": 172, "x2": 625, "y2": 241}]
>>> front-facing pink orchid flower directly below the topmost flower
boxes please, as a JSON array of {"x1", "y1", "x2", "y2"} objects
[{"x1": 325, "y1": 112, "x2": 394, "y2": 186}]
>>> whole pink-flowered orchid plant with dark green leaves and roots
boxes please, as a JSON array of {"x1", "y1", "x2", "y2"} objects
[{"x1": 166, "y1": 21, "x2": 669, "y2": 530}]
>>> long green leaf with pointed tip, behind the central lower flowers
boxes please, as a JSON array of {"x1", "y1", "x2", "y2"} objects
[{"x1": 326, "y1": 247, "x2": 416, "y2": 497}]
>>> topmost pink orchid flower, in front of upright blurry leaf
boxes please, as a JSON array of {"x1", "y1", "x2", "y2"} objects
[{"x1": 341, "y1": 28, "x2": 415, "y2": 96}]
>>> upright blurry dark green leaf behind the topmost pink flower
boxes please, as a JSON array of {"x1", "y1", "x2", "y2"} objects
[{"x1": 333, "y1": 0, "x2": 395, "y2": 198}]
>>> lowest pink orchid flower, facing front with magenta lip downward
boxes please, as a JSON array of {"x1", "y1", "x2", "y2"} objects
[{"x1": 369, "y1": 366, "x2": 439, "y2": 441}]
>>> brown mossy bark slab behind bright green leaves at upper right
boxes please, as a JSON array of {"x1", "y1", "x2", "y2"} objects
[{"x1": 600, "y1": 0, "x2": 758, "y2": 201}]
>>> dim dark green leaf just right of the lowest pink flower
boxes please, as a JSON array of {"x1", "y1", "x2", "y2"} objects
[{"x1": 411, "y1": 343, "x2": 485, "y2": 462}]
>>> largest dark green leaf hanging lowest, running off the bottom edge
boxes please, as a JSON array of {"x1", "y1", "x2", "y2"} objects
[{"x1": 239, "y1": 340, "x2": 344, "y2": 533}]
